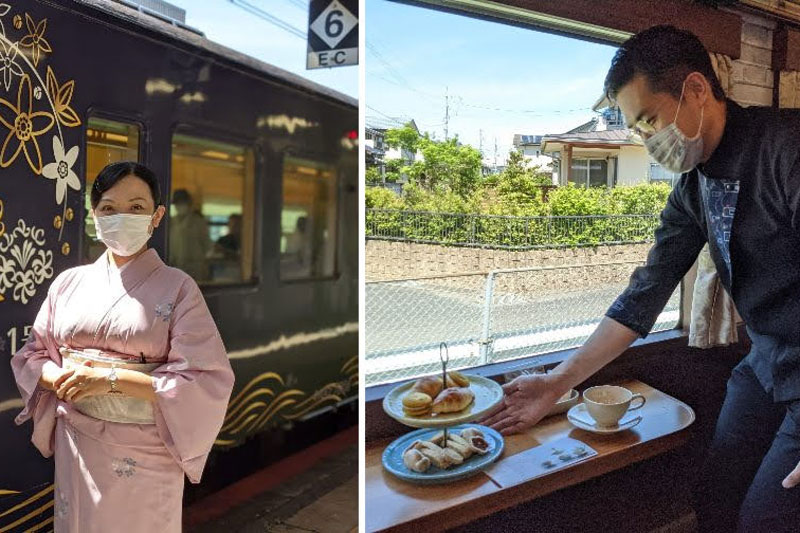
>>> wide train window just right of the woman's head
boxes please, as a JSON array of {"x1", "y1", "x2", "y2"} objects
[{"x1": 167, "y1": 134, "x2": 255, "y2": 285}]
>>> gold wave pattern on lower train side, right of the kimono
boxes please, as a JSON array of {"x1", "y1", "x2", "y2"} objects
[{"x1": 214, "y1": 356, "x2": 358, "y2": 446}]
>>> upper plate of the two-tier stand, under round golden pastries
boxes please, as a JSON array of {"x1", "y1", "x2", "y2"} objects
[{"x1": 383, "y1": 374, "x2": 503, "y2": 428}]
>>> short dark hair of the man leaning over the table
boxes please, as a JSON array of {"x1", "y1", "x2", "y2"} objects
[{"x1": 605, "y1": 25, "x2": 725, "y2": 100}]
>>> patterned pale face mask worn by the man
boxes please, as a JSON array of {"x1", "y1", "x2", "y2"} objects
[{"x1": 644, "y1": 82, "x2": 704, "y2": 173}]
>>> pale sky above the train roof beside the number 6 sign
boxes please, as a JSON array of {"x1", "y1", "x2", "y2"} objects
[{"x1": 168, "y1": 0, "x2": 358, "y2": 98}]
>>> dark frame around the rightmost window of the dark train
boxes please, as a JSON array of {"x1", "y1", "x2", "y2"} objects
[{"x1": 275, "y1": 148, "x2": 342, "y2": 286}]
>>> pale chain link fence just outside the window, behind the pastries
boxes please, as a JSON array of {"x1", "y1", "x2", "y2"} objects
[{"x1": 365, "y1": 261, "x2": 680, "y2": 385}]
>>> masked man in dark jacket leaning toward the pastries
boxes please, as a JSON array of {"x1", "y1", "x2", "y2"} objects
[{"x1": 487, "y1": 26, "x2": 800, "y2": 533}]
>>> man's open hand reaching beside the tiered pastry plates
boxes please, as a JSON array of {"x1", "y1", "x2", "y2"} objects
[{"x1": 480, "y1": 374, "x2": 563, "y2": 435}]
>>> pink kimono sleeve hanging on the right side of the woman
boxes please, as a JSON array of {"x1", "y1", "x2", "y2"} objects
[{"x1": 152, "y1": 277, "x2": 233, "y2": 483}]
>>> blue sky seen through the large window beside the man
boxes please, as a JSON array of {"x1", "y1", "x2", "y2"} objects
[{"x1": 366, "y1": 0, "x2": 616, "y2": 163}]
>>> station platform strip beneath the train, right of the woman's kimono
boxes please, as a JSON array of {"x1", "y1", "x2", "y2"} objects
[{"x1": 184, "y1": 428, "x2": 358, "y2": 533}]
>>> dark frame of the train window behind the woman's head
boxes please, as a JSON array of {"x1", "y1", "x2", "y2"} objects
[{"x1": 78, "y1": 106, "x2": 151, "y2": 265}]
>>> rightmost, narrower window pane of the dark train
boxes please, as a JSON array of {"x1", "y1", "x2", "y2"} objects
[{"x1": 280, "y1": 157, "x2": 337, "y2": 280}]
